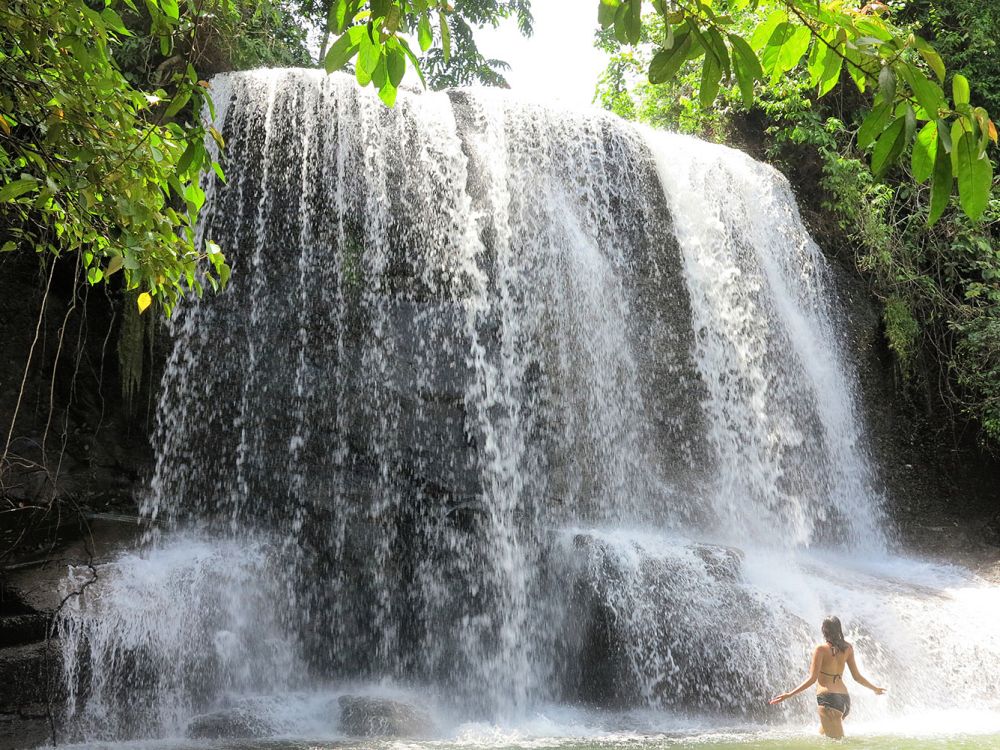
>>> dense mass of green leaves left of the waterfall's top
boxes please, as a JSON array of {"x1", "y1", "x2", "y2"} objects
[{"x1": 0, "y1": 0, "x2": 229, "y2": 313}]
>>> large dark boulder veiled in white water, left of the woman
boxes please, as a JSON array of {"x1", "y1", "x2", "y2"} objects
[{"x1": 566, "y1": 534, "x2": 785, "y2": 714}]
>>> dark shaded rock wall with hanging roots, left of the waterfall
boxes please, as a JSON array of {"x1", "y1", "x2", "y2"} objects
[{"x1": 0, "y1": 253, "x2": 161, "y2": 565}]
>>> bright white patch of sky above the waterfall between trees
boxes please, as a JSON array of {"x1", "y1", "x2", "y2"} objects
[{"x1": 476, "y1": 0, "x2": 607, "y2": 106}]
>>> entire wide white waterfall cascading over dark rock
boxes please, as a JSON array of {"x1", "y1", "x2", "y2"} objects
[{"x1": 60, "y1": 71, "x2": 1000, "y2": 738}]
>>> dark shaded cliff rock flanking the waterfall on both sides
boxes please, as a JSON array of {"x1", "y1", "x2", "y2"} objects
[{"x1": 0, "y1": 135, "x2": 1000, "y2": 747}]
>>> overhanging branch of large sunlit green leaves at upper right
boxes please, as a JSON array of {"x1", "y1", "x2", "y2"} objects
[{"x1": 598, "y1": 0, "x2": 997, "y2": 222}]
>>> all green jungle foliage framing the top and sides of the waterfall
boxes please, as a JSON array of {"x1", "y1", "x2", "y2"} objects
[{"x1": 0, "y1": 0, "x2": 1000, "y2": 452}]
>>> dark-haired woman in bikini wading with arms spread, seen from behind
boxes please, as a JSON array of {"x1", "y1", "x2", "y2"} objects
[{"x1": 771, "y1": 617, "x2": 885, "y2": 740}]
